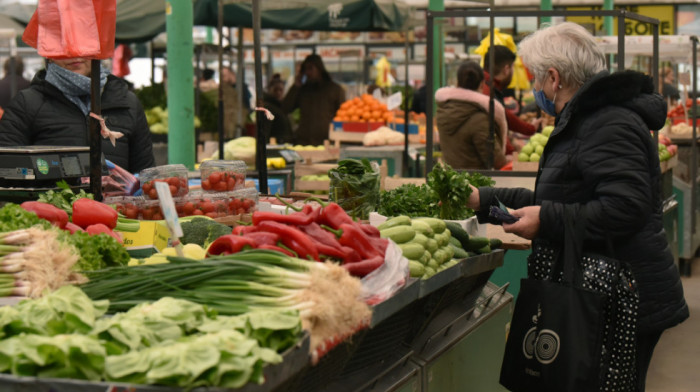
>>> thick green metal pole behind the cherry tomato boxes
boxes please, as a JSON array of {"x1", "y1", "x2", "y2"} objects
[{"x1": 165, "y1": 0, "x2": 195, "y2": 170}]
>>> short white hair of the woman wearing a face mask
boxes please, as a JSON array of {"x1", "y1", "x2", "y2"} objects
[{"x1": 518, "y1": 22, "x2": 606, "y2": 88}]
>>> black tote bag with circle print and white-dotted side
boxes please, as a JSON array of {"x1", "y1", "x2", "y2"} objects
[{"x1": 500, "y1": 206, "x2": 639, "y2": 392}]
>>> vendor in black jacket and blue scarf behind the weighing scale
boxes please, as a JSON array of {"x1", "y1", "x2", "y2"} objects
[{"x1": 0, "y1": 58, "x2": 155, "y2": 173}]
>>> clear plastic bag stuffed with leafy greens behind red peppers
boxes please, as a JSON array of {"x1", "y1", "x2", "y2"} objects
[{"x1": 328, "y1": 159, "x2": 380, "y2": 220}]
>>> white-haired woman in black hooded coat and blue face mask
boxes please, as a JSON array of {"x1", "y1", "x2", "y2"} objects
[{"x1": 469, "y1": 22, "x2": 688, "y2": 391}]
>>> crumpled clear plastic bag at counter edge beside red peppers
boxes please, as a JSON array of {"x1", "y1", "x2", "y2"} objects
[{"x1": 362, "y1": 240, "x2": 410, "y2": 305}]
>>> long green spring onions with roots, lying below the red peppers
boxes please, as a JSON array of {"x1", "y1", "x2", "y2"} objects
[{"x1": 82, "y1": 249, "x2": 371, "y2": 350}]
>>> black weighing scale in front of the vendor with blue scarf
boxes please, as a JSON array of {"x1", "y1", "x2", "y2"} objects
[{"x1": 0, "y1": 146, "x2": 105, "y2": 202}]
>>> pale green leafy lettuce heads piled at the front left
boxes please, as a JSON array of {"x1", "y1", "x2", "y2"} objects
[{"x1": 0, "y1": 286, "x2": 301, "y2": 388}]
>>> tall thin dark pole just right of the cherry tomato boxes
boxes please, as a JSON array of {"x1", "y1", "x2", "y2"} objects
[{"x1": 253, "y1": 0, "x2": 267, "y2": 194}]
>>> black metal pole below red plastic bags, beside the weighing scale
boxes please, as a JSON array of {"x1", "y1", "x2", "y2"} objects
[{"x1": 88, "y1": 60, "x2": 102, "y2": 201}]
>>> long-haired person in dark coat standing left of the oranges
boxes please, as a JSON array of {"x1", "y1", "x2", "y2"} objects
[{"x1": 282, "y1": 54, "x2": 345, "y2": 145}]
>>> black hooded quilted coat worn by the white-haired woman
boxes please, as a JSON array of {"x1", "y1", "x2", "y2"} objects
[{"x1": 478, "y1": 71, "x2": 688, "y2": 333}]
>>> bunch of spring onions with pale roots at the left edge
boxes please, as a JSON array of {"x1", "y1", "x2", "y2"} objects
[{"x1": 0, "y1": 227, "x2": 85, "y2": 298}]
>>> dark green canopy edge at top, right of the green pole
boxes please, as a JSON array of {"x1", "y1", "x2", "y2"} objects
[{"x1": 194, "y1": 0, "x2": 410, "y2": 31}]
